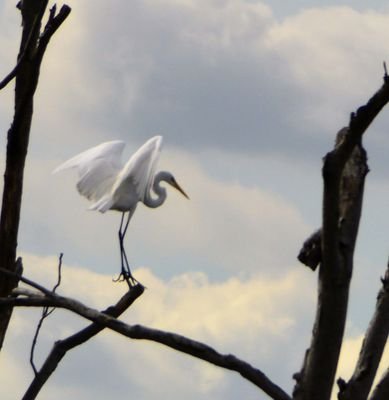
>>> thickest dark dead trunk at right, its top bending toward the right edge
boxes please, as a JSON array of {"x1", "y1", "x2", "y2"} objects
[{"x1": 294, "y1": 69, "x2": 389, "y2": 400}]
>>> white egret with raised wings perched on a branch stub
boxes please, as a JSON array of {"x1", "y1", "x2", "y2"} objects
[{"x1": 53, "y1": 136, "x2": 189, "y2": 288}]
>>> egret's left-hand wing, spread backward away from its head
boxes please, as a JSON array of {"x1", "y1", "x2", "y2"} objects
[{"x1": 53, "y1": 140, "x2": 125, "y2": 202}]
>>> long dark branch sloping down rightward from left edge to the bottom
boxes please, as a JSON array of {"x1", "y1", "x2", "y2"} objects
[{"x1": 0, "y1": 285, "x2": 291, "y2": 400}]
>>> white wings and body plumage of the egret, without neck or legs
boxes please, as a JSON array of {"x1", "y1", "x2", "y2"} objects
[{"x1": 53, "y1": 136, "x2": 162, "y2": 212}]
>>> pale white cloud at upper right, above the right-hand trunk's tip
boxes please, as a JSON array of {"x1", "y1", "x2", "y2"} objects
[{"x1": 265, "y1": 6, "x2": 389, "y2": 135}]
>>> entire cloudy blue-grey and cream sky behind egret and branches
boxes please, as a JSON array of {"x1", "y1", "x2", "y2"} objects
[{"x1": 0, "y1": 0, "x2": 389, "y2": 400}]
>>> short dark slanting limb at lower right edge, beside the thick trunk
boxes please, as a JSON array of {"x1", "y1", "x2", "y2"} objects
[{"x1": 338, "y1": 263, "x2": 389, "y2": 400}]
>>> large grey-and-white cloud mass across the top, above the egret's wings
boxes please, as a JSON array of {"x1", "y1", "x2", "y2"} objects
[{"x1": 17, "y1": 0, "x2": 388, "y2": 163}]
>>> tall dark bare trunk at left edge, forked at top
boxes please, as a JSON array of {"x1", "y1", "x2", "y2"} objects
[{"x1": 0, "y1": 0, "x2": 70, "y2": 349}]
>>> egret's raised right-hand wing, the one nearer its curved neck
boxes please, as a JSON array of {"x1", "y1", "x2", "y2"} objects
[{"x1": 114, "y1": 136, "x2": 162, "y2": 201}]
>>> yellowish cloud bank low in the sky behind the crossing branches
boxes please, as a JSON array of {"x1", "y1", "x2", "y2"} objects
[{"x1": 0, "y1": 254, "x2": 314, "y2": 400}]
